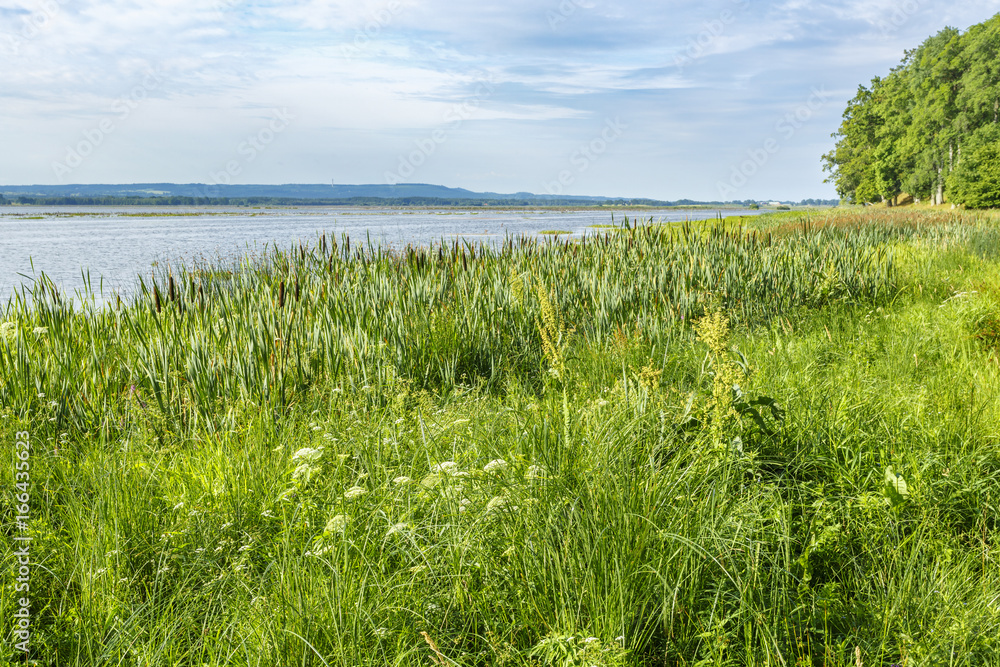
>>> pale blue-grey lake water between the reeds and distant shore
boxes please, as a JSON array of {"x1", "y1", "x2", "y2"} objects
[{"x1": 0, "y1": 206, "x2": 756, "y2": 304}]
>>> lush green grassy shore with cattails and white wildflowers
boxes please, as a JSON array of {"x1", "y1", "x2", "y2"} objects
[{"x1": 0, "y1": 208, "x2": 1000, "y2": 667}]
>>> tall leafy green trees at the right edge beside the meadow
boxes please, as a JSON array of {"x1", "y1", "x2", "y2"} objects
[{"x1": 823, "y1": 14, "x2": 1000, "y2": 208}]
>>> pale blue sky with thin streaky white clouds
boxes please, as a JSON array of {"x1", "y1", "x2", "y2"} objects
[{"x1": 0, "y1": 0, "x2": 1000, "y2": 201}]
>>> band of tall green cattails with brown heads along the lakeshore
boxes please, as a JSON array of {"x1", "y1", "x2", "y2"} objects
[{"x1": 0, "y1": 221, "x2": 894, "y2": 427}]
